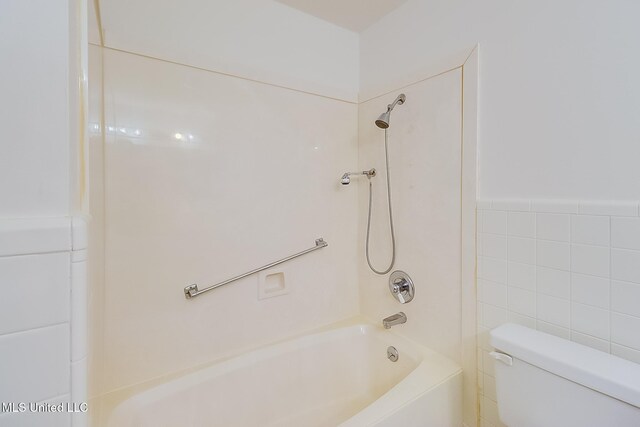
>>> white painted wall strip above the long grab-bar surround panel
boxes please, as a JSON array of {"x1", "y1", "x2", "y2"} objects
[{"x1": 95, "y1": 0, "x2": 358, "y2": 101}]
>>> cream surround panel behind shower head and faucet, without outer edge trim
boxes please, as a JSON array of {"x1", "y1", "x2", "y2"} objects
[{"x1": 358, "y1": 68, "x2": 462, "y2": 363}]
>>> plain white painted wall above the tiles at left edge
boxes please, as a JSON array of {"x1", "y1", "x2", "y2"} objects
[{"x1": 0, "y1": 0, "x2": 71, "y2": 217}]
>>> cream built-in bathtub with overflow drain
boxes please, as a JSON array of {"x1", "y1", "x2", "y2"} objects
[{"x1": 107, "y1": 323, "x2": 462, "y2": 427}]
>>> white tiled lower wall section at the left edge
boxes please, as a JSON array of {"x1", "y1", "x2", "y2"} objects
[{"x1": 0, "y1": 217, "x2": 87, "y2": 427}]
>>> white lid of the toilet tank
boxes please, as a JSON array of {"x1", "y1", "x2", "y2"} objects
[{"x1": 490, "y1": 323, "x2": 640, "y2": 407}]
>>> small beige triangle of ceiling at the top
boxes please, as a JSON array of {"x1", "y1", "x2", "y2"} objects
[{"x1": 276, "y1": 0, "x2": 407, "y2": 33}]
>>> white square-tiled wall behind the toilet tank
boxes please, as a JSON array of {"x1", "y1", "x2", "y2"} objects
[{"x1": 477, "y1": 200, "x2": 640, "y2": 426}]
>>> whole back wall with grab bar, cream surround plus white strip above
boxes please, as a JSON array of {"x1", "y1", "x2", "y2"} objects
[{"x1": 90, "y1": 0, "x2": 358, "y2": 408}]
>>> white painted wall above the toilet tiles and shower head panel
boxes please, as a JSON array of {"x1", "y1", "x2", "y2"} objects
[{"x1": 360, "y1": 0, "x2": 640, "y2": 200}]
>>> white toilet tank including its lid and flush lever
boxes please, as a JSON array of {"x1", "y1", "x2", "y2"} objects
[{"x1": 491, "y1": 323, "x2": 640, "y2": 427}]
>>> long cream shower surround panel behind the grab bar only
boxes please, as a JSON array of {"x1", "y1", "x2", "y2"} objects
[{"x1": 89, "y1": 48, "x2": 358, "y2": 400}]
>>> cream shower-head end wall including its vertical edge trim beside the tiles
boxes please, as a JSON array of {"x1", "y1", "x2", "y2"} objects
[{"x1": 358, "y1": 62, "x2": 478, "y2": 425}]
